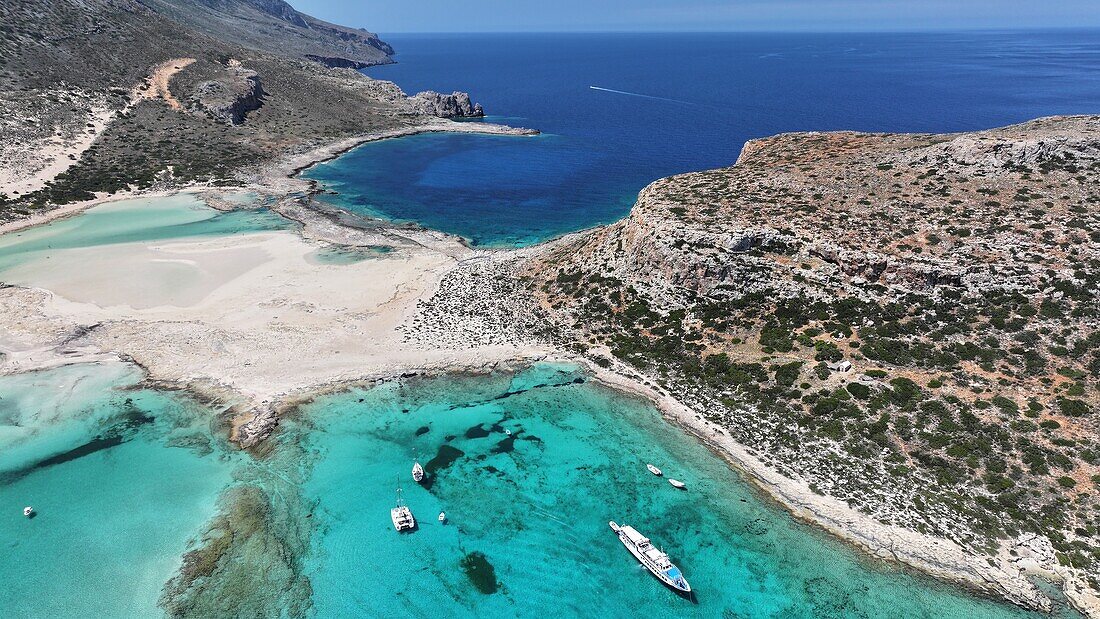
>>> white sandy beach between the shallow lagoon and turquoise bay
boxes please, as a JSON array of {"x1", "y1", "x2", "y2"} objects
[{"x1": 3, "y1": 205, "x2": 550, "y2": 405}]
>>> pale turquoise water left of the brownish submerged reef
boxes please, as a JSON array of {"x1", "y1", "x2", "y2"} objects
[{"x1": 0, "y1": 364, "x2": 238, "y2": 618}]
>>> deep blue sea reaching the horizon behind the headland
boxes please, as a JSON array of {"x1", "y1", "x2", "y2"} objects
[{"x1": 306, "y1": 31, "x2": 1100, "y2": 245}]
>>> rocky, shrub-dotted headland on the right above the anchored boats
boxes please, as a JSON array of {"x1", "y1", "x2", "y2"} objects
[{"x1": 527, "y1": 117, "x2": 1100, "y2": 611}]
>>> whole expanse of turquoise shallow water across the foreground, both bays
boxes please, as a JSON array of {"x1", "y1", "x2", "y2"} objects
[{"x1": 0, "y1": 365, "x2": 1071, "y2": 618}]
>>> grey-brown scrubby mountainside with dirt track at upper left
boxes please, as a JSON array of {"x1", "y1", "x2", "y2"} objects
[{"x1": 0, "y1": 0, "x2": 463, "y2": 221}]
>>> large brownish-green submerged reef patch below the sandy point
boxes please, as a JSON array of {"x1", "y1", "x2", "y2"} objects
[{"x1": 160, "y1": 428, "x2": 314, "y2": 617}]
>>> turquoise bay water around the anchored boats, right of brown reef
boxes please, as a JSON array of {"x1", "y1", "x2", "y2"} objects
[{"x1": 290, "y1": 366, "x2": 1056, "y2": 618}]
